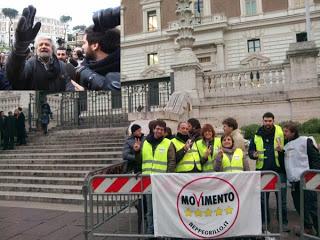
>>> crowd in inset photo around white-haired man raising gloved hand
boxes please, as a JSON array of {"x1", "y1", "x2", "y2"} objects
[{"x1": 0, "y1": 6, "x2": 121, "y2": 91}]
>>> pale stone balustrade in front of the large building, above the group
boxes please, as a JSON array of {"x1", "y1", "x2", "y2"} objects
[{"x1": 203, "y1": 64, "x2": 287, "y2": 97}]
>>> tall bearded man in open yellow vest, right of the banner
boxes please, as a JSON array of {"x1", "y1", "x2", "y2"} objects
[{"x1": 248, "y1": 112, "x2": 290, "y2": 232}]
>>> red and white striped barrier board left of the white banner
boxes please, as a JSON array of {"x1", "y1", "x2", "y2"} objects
[{"x1": 91, "y1": 176, "x2": 151, "y2": 193}]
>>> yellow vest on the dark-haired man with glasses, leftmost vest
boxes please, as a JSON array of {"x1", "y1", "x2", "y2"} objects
[{"x1": 141, "y1": 138, "x2": 171, "y2": 174}]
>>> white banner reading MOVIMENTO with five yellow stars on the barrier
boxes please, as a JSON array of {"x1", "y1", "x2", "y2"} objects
[{"x1": 151, "y1": 172, "x2": 262, "y2": 239}]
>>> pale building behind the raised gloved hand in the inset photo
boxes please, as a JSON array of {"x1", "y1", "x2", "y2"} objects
[{"x1": 0, "y1": 9, "x2": 65, "y2": 49}]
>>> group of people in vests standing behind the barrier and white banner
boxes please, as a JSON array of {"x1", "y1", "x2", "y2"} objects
[{"x1": 123, "y1": 112, "x2": 320, "y2": 234}]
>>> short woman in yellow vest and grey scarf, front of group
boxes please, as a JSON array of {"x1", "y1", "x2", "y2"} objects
[{"x1": 214, "y1": 135, "x2": 250, "y2": 173}]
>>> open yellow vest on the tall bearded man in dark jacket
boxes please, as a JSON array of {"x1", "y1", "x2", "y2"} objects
[{"x1": 254, "y1": 125, "x2": 284, "y2": 169}]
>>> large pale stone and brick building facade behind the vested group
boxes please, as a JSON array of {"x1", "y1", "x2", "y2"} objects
[{"x1": 121, "y1": 0, "x2": 320, "y2": 124}]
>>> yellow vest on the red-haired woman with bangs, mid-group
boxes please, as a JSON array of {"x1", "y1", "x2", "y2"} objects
[{"x1": 196, "y1": 137, "x2": 221, "y2": 172}]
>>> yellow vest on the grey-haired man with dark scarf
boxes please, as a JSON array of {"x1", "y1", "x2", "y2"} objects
[{"x1": 171, "y1": 138, "x2": 202, "y2": 172}]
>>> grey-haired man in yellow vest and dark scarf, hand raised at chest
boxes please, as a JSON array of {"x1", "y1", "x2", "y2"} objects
[{"x1": 171, "y1": 122, "x2": 202, "y2": 173}]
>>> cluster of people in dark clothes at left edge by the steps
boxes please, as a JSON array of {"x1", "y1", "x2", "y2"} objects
[{"x1": 0, "y1": 107, "x2": 27, "y2": 150}]
